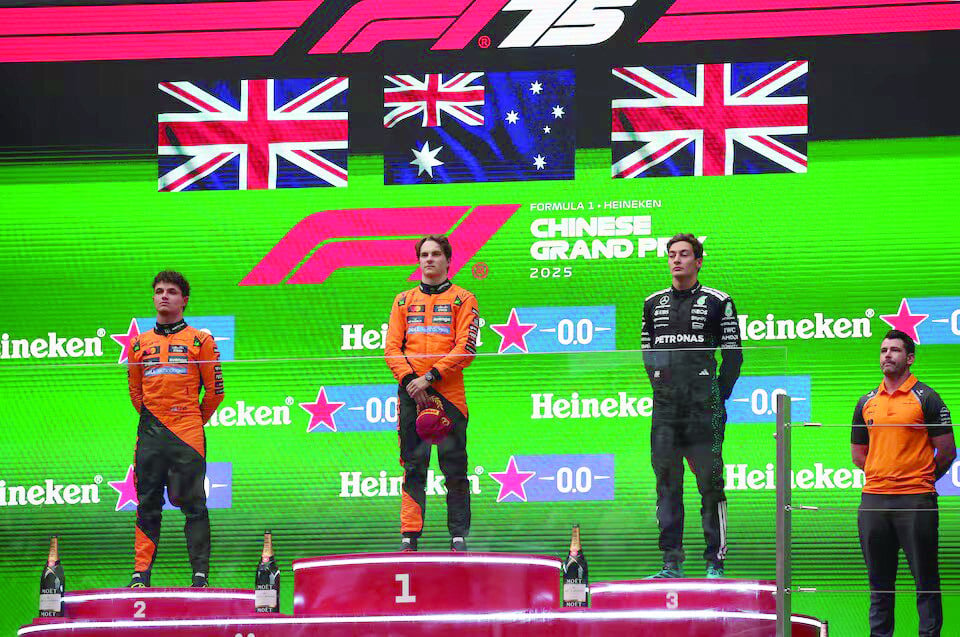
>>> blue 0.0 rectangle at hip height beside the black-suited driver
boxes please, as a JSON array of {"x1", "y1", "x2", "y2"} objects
[{"x1": 727, "y1": 376, "x2": 810, "y2": 423}]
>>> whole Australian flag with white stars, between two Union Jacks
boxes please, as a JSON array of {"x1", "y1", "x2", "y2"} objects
[{"x1": 383, "y1": 71, "x2": 576, "y2": 184}]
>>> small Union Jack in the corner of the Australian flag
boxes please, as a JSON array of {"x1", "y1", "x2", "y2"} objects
[{"x1": 383, "y1": 73, "x2": 484, "y2": 128}]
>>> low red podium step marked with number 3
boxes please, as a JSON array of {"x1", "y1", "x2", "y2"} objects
[{"x1": 590, "y1": 579, "x2": 777, "y2": 613}]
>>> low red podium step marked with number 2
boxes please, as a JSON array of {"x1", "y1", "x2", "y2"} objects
[{"x1": 64, "y1": 588, "x2": 256, "y2": 620}]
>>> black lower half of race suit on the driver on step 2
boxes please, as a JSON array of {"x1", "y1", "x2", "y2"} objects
[{"x1": 134, "y1": 407, "x2": 210, "y2": 573}]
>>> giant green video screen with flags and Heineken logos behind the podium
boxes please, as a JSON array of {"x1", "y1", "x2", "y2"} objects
[{"x1": 0, "y1": 0, "x2": 960, "y2": 635}]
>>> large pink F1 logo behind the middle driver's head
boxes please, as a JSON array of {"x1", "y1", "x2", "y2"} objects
[{"x1": 240, "y1": 204, "x2": 520, "y2": 285}]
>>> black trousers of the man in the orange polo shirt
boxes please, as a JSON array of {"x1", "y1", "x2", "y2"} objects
[{"x1": 857, "y1": 493, "x2": 943, "y2": 637}]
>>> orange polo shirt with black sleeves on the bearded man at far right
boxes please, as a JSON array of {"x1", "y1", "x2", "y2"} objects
[{"x1": 850, "y1": 374, "x2": 953, "y2": 494}]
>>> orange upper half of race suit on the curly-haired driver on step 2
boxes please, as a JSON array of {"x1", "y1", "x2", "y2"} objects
[{"x1": 127, "y1": 320, "x2": 223, "y2": 456}]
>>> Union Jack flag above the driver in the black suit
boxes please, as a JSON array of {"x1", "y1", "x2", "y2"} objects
[{"x1": 611, "y1": 60, "x2": 807, "y2": 178}]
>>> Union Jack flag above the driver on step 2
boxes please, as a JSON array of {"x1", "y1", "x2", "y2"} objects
[{"x1": 157, "y1": 77, "x2": 348, "y2": 191}]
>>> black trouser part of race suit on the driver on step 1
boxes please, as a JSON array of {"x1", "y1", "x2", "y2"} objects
[{"x1": 397, "y1": 387, "x2": 470, "y2": 537}]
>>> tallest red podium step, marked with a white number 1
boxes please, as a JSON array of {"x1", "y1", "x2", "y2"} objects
[{"x1": 293, "y1": 552, "x2": 561, "y2": 616}]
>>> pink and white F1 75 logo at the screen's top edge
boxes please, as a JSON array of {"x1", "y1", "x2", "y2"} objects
[{"x1": 310, "y1": 0, "x2": 636, "y2": 53}]
